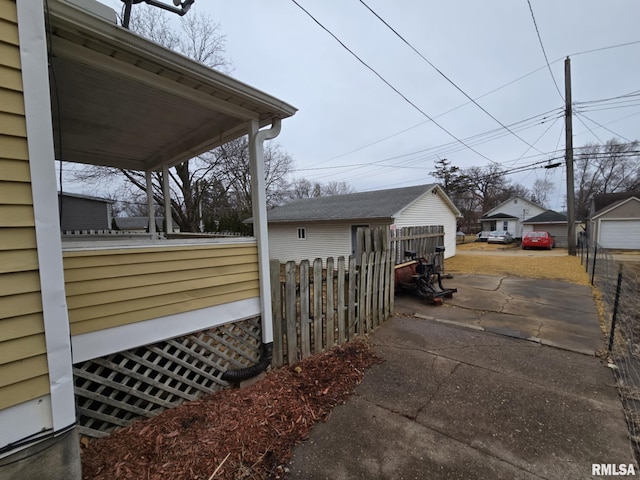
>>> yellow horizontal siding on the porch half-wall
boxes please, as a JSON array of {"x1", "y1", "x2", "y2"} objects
[{"x1": 64, "y1": 243, "x2": 259, "y2": 335}]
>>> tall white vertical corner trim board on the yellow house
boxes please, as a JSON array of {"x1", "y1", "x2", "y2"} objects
[{"x1": 16, "y1": 0, "x2": 76, "y2": 433}]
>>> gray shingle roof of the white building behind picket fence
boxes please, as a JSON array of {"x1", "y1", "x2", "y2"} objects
[{"x1": 267, "y1": 183, "x2": 437, "y2": 223}]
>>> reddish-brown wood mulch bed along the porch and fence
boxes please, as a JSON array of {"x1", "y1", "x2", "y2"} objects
[{"x1": 82, "y1": 341, "x2": 380, "y2": 480}]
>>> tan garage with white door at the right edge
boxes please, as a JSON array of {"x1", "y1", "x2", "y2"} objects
[{"x1": 591, "y1": 197, "x2": 640, "y2": 250}]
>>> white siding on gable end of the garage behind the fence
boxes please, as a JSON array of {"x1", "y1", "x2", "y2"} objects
[{"x1": 395, "y1": 192, "x2": 457, "y2": 258}]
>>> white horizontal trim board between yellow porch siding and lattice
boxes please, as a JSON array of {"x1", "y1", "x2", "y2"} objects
[{"x1": 71, "y1": 297, "x2": 260, "y2": 363}]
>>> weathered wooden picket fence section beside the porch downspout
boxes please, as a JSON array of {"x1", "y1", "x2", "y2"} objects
[{"x1": 271, "y1": 250, "x2": 394, "y2": 366}]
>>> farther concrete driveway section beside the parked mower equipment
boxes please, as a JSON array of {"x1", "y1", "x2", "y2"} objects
[{"x1": 396, "y1": 275, "x2": 604, "y2": 355}]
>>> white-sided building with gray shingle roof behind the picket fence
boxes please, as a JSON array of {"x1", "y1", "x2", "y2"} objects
[{"x1": 267, "y1": 184, "x2": 461, "y2": 261}]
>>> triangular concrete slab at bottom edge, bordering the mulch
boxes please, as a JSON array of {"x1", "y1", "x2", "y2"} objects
[{"x1": 287, "y1": 398, "x2": 539, "y2": 480}]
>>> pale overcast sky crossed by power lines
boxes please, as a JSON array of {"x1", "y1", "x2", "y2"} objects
[{"x1": 92, "y1": 0, "x2": 640, "y2": 209}]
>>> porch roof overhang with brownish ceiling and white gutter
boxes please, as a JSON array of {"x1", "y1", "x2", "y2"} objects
[{"x1": 45, "y1": 0, "x2": 296, "y2": 171}]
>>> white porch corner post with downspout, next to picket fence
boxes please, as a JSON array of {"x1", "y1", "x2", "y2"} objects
[{"x1": 249, "y1": 118, "x2": 282, "y2": 344}]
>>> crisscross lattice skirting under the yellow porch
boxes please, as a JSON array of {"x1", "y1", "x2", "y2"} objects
[{"x1": 73, "y1": 317, "x2": 261, "y2": 437}]
